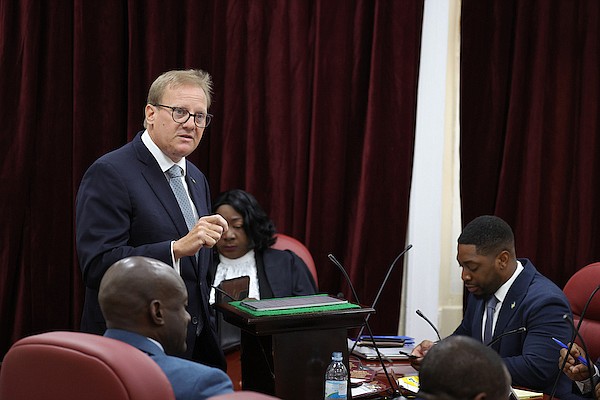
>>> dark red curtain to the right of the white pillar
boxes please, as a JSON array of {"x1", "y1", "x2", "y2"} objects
[{"x1": 461, "y1": 0, "x2": 600, "y2": 287}]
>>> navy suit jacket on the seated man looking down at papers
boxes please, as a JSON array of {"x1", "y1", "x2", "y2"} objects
[{"x1": 454, "y1": 259, "x2": 571, "y2": 399}]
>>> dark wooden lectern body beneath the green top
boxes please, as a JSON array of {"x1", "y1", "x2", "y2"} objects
[{"x1": 216, "y1": 303, "x2": 375, "y2": 400}]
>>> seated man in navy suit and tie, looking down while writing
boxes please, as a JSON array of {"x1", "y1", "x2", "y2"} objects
[{"x1": 411, "y1": 215, "x2": 573, "y2": 400}]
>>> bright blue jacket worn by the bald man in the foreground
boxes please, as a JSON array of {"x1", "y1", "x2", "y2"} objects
[{"x1": 104, "y1": 329, "x2": 233, "y2": 400}]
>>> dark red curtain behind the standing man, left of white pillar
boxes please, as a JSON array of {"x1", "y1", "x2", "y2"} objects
[{"x1": 0, "y1": 0, "x2": 423, "y2": 356}]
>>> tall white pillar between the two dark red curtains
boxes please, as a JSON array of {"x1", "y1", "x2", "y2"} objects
[{"x1": 399, "y1": 0, "x2": 462, "y2": 343}]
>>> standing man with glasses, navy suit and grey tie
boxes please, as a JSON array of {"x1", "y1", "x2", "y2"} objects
[{"x1": 76, "y1": 70, "x2": 227, "y2": 370}]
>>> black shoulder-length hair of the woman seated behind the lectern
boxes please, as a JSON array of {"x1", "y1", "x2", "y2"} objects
[{"x1": 213, "y1": 189, "x2": 276, "y2": 251}]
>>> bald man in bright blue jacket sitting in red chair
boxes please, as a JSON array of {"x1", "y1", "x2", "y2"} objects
[{"x1": 98, "y1": 257, "x2": 233, "y2": 400}]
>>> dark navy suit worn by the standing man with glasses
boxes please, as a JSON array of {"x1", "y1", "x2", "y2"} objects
[{"x1": 76, "y1": 132, "x2": 226, "y2": 368}]
